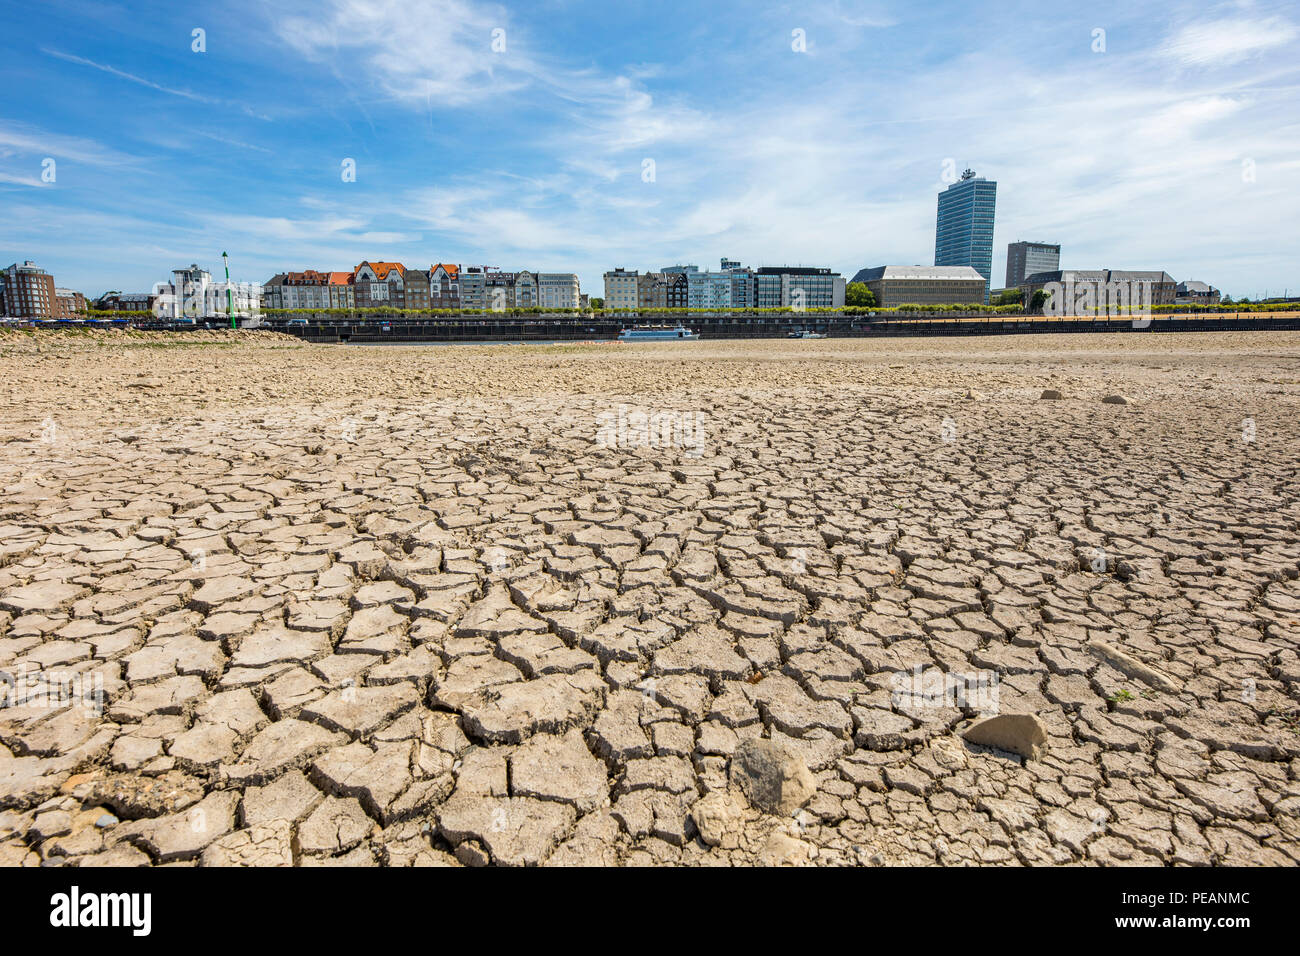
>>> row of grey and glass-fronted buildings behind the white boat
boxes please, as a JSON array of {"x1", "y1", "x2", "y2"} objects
[{"x1": 605, "y1": 259, "x2": 845, "y2": 310}]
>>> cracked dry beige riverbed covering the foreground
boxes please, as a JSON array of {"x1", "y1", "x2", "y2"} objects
[{"x1": 0, "y1": 333, "x2": 1300, "y2": 866}]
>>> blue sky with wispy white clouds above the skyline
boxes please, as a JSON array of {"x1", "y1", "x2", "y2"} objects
[{"x1": 0, "y1": 0, "x2": 1300, "y2": 297}]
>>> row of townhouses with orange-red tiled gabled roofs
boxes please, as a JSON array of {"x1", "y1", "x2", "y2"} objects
[{"x1": 263, "y1": 261, "x2": 582, "y2": 311}]
